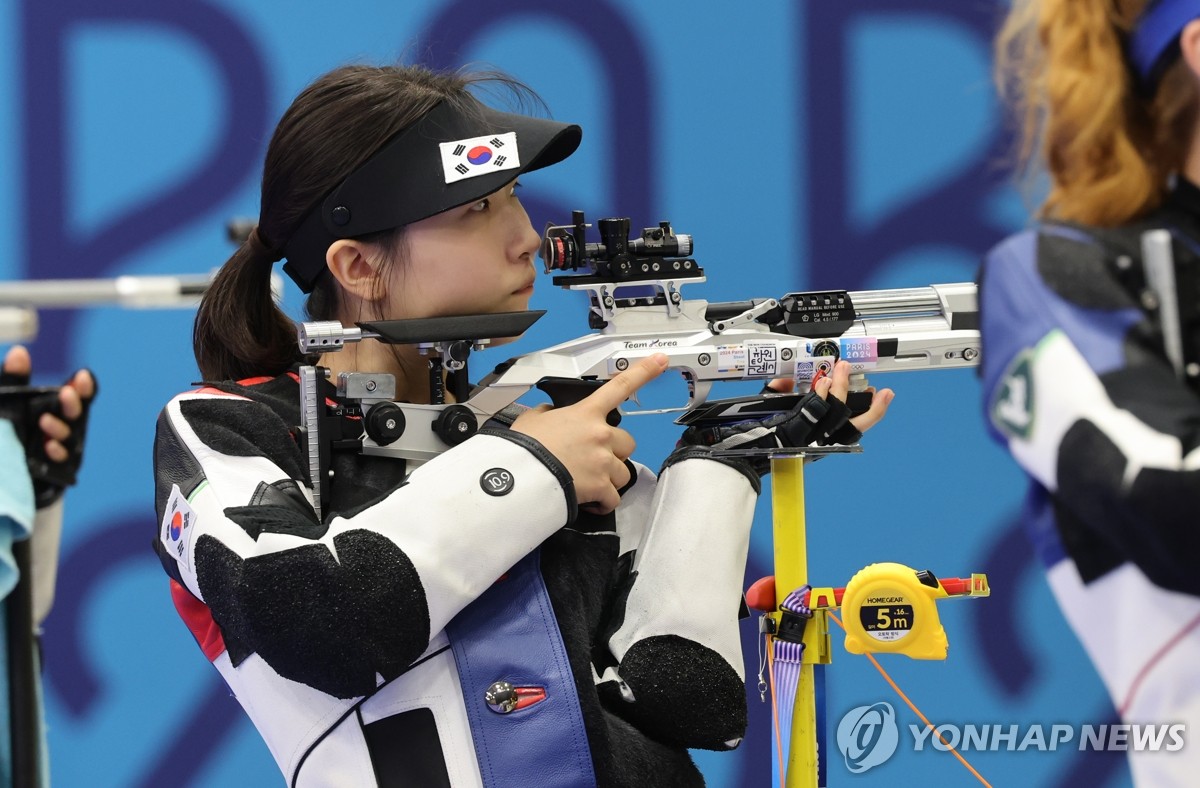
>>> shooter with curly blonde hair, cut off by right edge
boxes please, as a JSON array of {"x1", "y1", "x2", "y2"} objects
[{"x1": 980, "y1": 0, "x2": 1200, "y2": 786}]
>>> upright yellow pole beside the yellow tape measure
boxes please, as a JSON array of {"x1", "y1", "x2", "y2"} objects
[{"x1": 770, "y1": 457, "x2": 829, "y2": 788}]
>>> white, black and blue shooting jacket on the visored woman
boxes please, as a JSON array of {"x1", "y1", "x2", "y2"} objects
[{"x1": 147, "y1": 374, "x2": 758, "y2": 788}]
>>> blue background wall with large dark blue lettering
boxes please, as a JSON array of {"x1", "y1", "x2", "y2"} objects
[{"x1": 0, "y1": 0, "x2": 1128, "y2": 788}]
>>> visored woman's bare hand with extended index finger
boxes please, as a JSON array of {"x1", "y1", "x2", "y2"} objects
[{"x1": 512, "y1": 354, "x2": 667, "y2": 515}]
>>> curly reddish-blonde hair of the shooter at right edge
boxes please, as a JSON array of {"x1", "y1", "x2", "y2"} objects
[{"x1": 996, "y1": 0, "x2": 1198, "y2": 227}]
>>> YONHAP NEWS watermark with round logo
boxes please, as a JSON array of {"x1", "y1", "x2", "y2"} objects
[{"x1": 836, "y1": 702, "x2": 1188, "y2": 774}]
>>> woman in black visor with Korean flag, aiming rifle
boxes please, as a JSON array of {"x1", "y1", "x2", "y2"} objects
[{"x1": 155, "y1": 67, "x2": 892, "y2": 788}]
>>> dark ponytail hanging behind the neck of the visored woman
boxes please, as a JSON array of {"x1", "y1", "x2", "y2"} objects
[{"x1": 192, "y1": 228, "x2": 301, "y2": 380}]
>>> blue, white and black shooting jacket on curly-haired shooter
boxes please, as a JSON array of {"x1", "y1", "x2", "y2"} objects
[{"x1": 979, "y1": 180, "x2": 1200, "y2": 786}]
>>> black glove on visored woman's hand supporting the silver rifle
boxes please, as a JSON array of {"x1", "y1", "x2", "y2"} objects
[{"x1": 677, "y1": 391, "x2": 863, "y2": 476}]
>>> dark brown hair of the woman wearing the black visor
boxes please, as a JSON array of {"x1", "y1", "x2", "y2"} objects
[{"x1": 192, "y1": 66, "x2": 536, "y2": 380}]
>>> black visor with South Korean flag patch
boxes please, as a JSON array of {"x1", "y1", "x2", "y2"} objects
[{"x1": 283, "y1": 95, "x2": 583, "y2": 293}]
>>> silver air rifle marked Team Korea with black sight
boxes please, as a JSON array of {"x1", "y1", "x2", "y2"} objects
[{"x1": 299, "y1": 211, "x2": 979, "y2": 515}]
